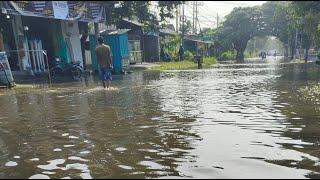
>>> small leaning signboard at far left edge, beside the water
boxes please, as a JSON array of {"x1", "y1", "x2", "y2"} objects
[{"x1": 0, "y1": 52, "x2": 13, "y2": 85}]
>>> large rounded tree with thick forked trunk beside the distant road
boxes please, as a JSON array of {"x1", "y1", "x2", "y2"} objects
[{"x1": 222, "y1": 7, "x2": 265, "y2": 62}]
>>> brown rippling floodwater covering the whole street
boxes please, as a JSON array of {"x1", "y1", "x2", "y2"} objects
[{"x1": 0, "y1": 58, "x2": 320, "y2": 178}]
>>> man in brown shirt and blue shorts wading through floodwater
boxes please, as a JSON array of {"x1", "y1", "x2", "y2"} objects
[{"x1": 95, "y1": 37, "x2": 112, "y2": 89}]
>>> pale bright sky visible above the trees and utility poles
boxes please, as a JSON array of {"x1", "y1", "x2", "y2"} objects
[{"x1": 160, "y1": 1, "x2": 267, "y2": 28}]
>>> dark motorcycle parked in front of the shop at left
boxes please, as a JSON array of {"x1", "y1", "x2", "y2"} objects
[{"x1": 50, "y1": 58, "x2": 83, "y2": 80}]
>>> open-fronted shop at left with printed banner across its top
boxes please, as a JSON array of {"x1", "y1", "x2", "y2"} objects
[{"x1": 0, "y1": 1, "x2": 108, "y2": 73}]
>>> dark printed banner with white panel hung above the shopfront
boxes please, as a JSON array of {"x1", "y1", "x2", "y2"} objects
[{"x1": 1, "y1": 1, "x2": 105, "y2": 23}]
